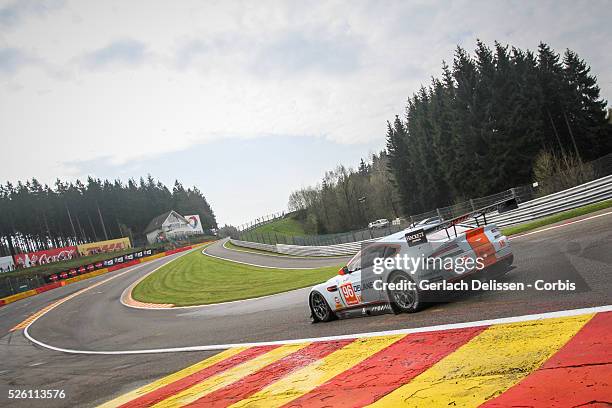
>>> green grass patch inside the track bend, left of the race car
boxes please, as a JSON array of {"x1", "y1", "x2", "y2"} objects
[{"x1": 132, "y1": 251, "x2": 340, "y2": 306}]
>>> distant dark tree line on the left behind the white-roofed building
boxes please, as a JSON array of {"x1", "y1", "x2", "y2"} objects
[{"x1": 0, "y1": 176, "x2": 217, "y2": 255}]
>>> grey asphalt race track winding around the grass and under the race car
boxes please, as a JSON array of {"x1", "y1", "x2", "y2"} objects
[{"x1": 0, "y1": 210, "x2": 612, "y2": 406}]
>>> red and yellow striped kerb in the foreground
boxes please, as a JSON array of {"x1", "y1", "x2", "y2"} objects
[{"x1": 102, "y1": 312, "x2": 612, "y2": 407}]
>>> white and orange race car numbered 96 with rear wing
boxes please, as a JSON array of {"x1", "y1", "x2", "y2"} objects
[{"x1": 308, "y1": 199, "x2": 518, "y2": 322}]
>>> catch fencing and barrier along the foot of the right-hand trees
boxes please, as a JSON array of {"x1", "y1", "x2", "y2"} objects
[{"x1": 231, "y1": 155, "x2": 612, "y2": 256}]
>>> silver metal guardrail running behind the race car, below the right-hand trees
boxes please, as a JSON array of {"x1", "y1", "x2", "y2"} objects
[{"x1": 231, "y1": 175, "x2": 612, "y2": 256}]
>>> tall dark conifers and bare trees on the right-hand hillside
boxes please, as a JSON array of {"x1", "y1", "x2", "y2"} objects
[{"x1": 289, "y1": 41, "x2": 612, "y2": 233}]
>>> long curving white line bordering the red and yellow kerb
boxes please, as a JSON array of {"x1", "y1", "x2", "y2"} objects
[{"x1": 24, "y1": 305, "x2": 612, "y2": 355}]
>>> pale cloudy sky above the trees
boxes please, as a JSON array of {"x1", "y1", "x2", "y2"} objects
[{"x1": 0, "y1": 0, "x2": 612, "y2": 224}]
